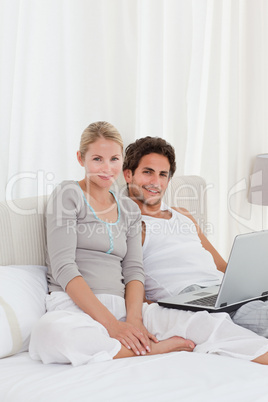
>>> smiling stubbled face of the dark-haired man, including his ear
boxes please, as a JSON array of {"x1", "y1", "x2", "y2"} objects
[{"x1": 124, "y1": 153, "x2": 170, "y2": 206}]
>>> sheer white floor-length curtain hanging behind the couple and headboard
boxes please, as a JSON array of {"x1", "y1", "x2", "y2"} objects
[{"x1": 0, "y1": 0, "x2": 268, "y2": 257}]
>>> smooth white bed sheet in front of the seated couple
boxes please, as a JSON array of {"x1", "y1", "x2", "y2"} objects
[{"x1": 0, "y1": 352, "x2": 268, "y2": 402}]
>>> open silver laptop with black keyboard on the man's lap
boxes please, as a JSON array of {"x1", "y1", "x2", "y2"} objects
[{"x1": 158, "y1": 230, "x2": 268, "y2": 313}]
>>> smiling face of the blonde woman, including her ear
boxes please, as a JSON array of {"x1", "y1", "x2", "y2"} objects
[{"x1": 77, "y1": 138, "x2": 123, "y2": 188}]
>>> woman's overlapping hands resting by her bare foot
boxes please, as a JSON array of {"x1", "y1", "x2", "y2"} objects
[{"x1": 107, "y1": 320, "x2": 158, "y2": 356}]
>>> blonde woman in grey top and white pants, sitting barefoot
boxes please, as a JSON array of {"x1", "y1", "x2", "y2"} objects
[{"x1": 29, "y1": 122, "x2": 268, "y2": 365}]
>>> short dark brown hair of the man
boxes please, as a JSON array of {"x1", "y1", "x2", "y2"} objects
[{"x1": 123, "y1": 136, "x2": 176, "y2": 177}]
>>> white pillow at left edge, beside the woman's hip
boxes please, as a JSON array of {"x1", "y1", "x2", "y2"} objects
[{"x1": 0, "y1": 265, "x2": 48, "y2": 358}]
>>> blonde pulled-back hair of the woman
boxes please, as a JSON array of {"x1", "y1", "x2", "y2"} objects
[{"x1": 79, "y1": 121, "x2": 123, "y2": 159}]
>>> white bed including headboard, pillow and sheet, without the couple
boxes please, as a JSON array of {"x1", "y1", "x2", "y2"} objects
[{"x1": 0, "y1": 176, "x2": 268, "y2": 402}]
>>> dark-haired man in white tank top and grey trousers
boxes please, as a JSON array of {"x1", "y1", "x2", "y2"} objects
[{"x1": 123, "y1": 137, "x2": 268, "y2": 337}]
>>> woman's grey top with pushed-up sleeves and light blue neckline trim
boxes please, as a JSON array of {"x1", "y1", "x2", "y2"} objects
[{"x1": 46, "y1": 181, "x2": 144, "y2": 297}]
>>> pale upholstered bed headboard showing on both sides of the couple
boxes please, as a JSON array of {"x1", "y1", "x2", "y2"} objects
[{"x1": 0, "y1": 176, "x2": 207, "y2": 265}]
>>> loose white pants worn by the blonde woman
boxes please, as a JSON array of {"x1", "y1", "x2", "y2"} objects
[{"x1": 29, "y1": 292, "x2": 268, "y2": 366}]
